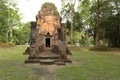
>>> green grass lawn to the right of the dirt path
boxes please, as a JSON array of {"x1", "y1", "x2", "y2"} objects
[{"x1": 56, "y1": 51, "x2": 120, "y2": 80}]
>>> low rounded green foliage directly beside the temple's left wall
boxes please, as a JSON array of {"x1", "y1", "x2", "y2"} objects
[{"x1": 13, "y1": 23, "x2": 30, "y2": 45}]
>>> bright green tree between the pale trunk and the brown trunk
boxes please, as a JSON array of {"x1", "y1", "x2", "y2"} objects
[{"x1": 78, "y1": 0, "x2": 92, "y2": 44}]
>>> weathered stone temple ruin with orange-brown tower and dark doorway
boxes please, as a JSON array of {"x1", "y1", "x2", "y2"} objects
[{"x1": 24, "y1": 2, "x2": 71, "y2": 64}]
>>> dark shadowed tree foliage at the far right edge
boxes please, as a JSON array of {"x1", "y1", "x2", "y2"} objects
[{"x1": 100, "y1": 0, "x2": 120, "y2": 47}]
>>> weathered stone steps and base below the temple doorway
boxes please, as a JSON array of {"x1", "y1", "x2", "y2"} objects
[{"x1": 25, "y1": 48, "x2": 71, "y2": 65}]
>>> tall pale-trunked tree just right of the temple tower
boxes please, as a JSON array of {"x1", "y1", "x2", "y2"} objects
[{"x1": 61, "y1": 0, "x2": 82, "y2": 44}]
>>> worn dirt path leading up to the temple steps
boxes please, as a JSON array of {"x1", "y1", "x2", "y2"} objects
[{"x1": 27, "y1": 64, "x2": 64, "y2": 80}]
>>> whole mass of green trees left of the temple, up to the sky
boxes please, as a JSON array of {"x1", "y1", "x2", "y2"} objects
[{"x1": 0, "y1": 0, "x2": 30, "y2": 44}]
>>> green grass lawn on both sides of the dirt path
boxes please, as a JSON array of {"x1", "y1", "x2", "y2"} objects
[{"x1": 0, "y1": 46, "x2": 120, "y2": 80}]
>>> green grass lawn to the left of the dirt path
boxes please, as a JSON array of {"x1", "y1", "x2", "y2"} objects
[{"x1": 0, "y1": 46, "x2": 39, "y2": 80}]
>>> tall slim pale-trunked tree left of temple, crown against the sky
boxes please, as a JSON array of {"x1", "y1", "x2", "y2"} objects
[{"x1": 7, "y1": 0, "x2": 21, "y2": 43}]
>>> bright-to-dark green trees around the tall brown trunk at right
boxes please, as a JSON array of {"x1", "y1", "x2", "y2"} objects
[{"x1": 78, "y1": 0, "x2": 120, "y2": 47}]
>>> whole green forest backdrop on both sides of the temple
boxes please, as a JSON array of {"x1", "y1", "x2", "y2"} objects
[{"x1": 0, "y1": 0, "x2": 120, "y2": 48}]
